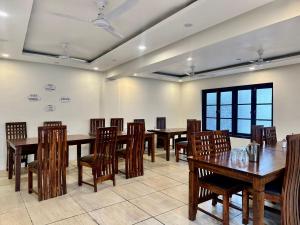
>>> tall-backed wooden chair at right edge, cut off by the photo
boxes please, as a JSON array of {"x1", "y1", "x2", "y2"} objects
[{"x1": 243, "y1": 134, "x2": 300, "y2": 225}]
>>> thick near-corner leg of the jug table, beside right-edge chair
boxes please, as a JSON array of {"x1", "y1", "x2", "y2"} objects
[{"x1": 253, "y1": 180, "x2": 265, "y2": 225}]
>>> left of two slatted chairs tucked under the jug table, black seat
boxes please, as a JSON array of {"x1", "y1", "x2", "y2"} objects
[{"x1": 190, "y1": 131, "x2": 244, "y2": 225}]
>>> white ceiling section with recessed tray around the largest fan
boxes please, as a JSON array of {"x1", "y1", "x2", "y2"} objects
[{"x1": 0, "y1": 0, "x2": 273, "y2": 71}]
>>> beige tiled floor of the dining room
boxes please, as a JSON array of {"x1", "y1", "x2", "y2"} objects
[{"x1": 0, "y1": 151, "x2": 280, "y2": 225}]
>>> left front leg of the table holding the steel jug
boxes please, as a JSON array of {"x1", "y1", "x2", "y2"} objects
[{"x1": 189, "y1": 162, "x2": 199, "y2": 221}]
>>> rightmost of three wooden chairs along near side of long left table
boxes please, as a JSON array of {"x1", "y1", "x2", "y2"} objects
[{"x1": 116, "y1": 123, "x2": 145, "y2": 179}]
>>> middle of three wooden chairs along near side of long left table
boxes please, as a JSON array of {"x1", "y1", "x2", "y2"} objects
[{"x1": 78, "y1": 127, "x2": 117, "y2": 192}]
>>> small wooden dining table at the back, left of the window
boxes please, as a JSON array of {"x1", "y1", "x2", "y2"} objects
[{"x1": 148, "y1": 128, "x2": 187, "y2": 161}]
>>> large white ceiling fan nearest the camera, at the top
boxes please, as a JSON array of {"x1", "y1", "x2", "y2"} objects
[{"x1": 48, "y1": 0, "x2": 138, "y2": 39}]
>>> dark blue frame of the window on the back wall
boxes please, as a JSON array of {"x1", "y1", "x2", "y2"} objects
[{"x1": 202, "y1": 83, "x2": 274, "y2": 139}]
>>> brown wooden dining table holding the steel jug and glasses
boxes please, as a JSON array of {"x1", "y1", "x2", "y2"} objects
[{"x1": 188, "y1": 143, "x2": 286, "y2": 225}]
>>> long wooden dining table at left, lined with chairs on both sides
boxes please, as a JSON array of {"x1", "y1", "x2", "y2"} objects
[{"x1": 7, "y1": 132, "x2": 155, "y2": 191}]
